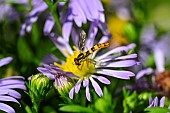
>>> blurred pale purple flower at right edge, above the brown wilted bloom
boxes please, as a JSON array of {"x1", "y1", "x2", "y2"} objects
[{"x1": 139, "y1": 25, "x2": 170, "y2": 72}]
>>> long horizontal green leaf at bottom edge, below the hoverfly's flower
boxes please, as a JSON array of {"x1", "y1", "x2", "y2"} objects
[{"x1": 59, "y1": 105, "x2": 93, "y2": 113}]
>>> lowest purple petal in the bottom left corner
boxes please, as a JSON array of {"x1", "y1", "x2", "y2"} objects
[{"x1": 0, "y1": 102, "x2": 15, "y2": 113}]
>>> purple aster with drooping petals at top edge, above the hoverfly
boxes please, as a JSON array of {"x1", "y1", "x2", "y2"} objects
[{"x1": 61, "y1": 0, "x2": 110, "y2": 41}]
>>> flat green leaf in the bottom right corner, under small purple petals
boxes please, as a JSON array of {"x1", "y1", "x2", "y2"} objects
[{"x1": 144, "y1": 107, "x2": 170, "y2": 113}]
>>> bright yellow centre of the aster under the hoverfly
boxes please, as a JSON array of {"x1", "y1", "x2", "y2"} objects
[{"x1": 54, "y1": 47, "x2": 96, "y2": 78}]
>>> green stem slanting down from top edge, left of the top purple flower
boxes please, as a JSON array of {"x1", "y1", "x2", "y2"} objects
[{"x1": 44, "y1": 0, "x2": 62, "y2": 36}]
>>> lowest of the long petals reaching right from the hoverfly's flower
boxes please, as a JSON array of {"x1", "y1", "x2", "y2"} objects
[{"x1": 97, "y1": 69, "x2": 135, "y2": 79}]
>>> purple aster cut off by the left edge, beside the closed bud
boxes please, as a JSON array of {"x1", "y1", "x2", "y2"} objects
[{"x1": 0, "y1": 57, "x2": 26, "y2": 113}]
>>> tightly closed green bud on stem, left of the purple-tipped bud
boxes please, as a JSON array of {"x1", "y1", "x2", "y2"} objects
[{"x1": 28, "y1": 74, "x2": 50, "y2": 111}]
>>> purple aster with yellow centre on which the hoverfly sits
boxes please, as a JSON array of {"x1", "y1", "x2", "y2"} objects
[{"x1": 38, "y1": 30, "x2": 138, "y2": 101}]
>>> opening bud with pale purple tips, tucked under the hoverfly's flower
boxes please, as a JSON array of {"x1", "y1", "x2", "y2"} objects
[{"x1": 54, "y1": 72, "x2": 74, "y2": 96}]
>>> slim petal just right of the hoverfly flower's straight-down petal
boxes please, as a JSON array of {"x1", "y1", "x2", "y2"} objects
[{"x1": 90, "y1": 77, "x2": 103, "y2": 97}]
